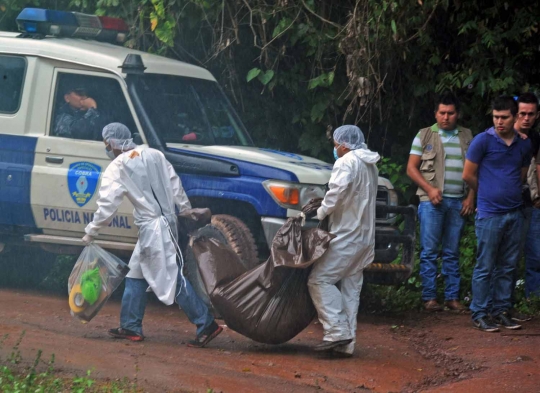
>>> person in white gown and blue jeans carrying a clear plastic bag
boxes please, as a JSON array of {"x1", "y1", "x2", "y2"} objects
[{"x1": 83, "y1": 123, "x2": 223, "y2": 347}]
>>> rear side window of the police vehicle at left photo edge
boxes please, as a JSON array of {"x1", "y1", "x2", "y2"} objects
[{"x1": 0, "y1": 55, "x2": 26, "y2": 113}]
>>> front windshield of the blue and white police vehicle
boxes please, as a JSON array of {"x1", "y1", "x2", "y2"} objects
[{"x1": 135, "y1": 74, "x2": 253, "y2": 146}]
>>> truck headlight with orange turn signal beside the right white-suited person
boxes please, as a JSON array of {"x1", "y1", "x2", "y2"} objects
[{"x1": 263, "y1": 180, "x2": 326, "y2": 210}]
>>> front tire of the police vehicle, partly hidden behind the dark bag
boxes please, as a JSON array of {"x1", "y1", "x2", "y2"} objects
[{"x1": 184, "y1": 214, "x2": 259, "y2": 314}]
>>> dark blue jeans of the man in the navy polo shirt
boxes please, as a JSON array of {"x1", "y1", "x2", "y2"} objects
[{"x1": 471, "y1": 210, "x2": 524, "y2": 320}]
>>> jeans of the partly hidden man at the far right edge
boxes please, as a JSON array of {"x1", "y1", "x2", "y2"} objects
[{"x1": 525, "y1": 208, "x2": 540, "y2": 297}]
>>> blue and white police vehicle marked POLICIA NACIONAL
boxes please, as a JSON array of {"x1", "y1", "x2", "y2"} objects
[{"x1": 0, "y1": 8, "x2": 415, "y2": 284}]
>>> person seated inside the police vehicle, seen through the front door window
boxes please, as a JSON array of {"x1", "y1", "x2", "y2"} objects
[{"x1": 54, "y1": 87, "x2": 103, "y2": 140}]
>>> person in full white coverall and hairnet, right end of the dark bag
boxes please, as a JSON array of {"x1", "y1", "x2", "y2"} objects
[{"x1": 308, "y1": 125, "x2": 380, "y2": 356}]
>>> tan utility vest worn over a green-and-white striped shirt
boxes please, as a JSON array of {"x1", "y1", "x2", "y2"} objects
[{"x1": 416, "y1": 124, "x2": 473, "y2": 201}]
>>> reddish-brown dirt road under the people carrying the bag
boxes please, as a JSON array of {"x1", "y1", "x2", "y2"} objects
[{"x1": 0, "y1": 290, "x2": 540, "y2": 393}]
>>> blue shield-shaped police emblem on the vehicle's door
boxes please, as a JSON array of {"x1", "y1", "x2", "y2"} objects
[{"x1": 68, "y1": 161, "x2": 101, "y2": 207}]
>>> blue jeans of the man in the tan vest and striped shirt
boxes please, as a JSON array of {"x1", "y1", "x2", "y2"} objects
[{"x1": 418, "y1": 197, "x2": 465, "y2": 301}]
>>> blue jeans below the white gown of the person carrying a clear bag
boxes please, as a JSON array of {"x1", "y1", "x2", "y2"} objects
[{"x1": 120, "y1": 272, "x2": 214, "y2": 335}]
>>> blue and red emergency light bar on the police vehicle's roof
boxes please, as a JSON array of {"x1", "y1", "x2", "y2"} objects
[{"x1": 17, "y1": 8, "x2": 128, "y2": 42}]
